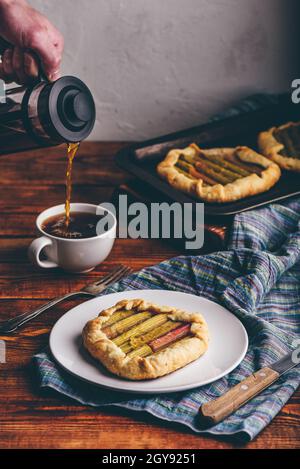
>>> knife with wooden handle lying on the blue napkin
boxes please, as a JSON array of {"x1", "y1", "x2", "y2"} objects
[{"x1": 199, "y1": 351, "x2": 300, "y2": 426}]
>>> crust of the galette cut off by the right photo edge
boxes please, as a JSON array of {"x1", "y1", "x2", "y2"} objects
[{"x1": 258, "y1": 122, "x2": 300, "y2": 172}]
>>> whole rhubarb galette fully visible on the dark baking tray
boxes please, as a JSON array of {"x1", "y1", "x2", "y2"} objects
[{"x1": 157, "y1": 143, "x2": 280, "y2": 202}]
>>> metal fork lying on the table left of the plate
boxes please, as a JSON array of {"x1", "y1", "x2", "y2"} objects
[{"x1": 0, "y1": 265, "x2": 132, "y2": 334}]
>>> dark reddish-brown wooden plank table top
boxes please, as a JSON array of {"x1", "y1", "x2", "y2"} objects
[{"x1": 0, "y1": 143, "x2": 300, "y2": 449}]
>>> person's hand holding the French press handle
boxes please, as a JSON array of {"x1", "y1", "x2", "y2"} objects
[{"x1": 0, "y1": 0, "x2": 64, "y2": 84}]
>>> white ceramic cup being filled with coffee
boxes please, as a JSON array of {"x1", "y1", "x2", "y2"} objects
[{"x1": 28, "y1": 203, "x2": 117, "y2": 273}]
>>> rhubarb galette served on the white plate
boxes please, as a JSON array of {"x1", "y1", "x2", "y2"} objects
[{"x1": 83, "y1": 299, "x2": 208, "y2": 380}]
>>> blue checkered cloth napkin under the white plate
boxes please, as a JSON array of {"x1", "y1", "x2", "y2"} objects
[{"x1": 34, "y1": 97, "x2": 300, "y2": 439}]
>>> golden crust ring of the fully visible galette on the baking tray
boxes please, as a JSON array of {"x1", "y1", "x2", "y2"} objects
[{"x1": 157, "y1": 143, "x2": 281, "y2": 203}]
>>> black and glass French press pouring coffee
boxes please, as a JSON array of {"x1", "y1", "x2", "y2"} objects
[{"x1": 0, "y1": 44, "x2": 96, "y2": 155}]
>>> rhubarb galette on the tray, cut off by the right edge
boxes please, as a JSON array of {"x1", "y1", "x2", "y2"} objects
[{"x1": 258, "y1": 122, "x2": 300, "y2": 171}]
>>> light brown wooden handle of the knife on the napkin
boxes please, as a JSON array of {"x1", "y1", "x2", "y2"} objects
[{"x1": 199, "y1": 367, "x2": 279, "y2": 426}]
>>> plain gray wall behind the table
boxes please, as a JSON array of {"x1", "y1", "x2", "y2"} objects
[{"x1": 29, "y1": 0, "x2": 300, "y2": 140}]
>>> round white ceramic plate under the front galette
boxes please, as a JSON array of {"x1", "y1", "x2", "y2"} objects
[{"x1": 50, "y1": 290, "x2": 248, "y2": 394}]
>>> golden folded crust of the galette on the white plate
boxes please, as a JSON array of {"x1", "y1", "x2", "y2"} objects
[{"x1": 82, "y1": 299, "x2": 209, "y2": 380}]
